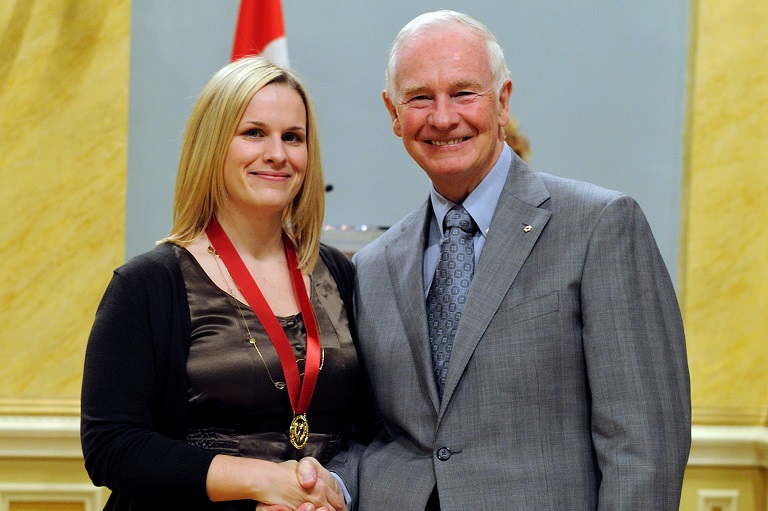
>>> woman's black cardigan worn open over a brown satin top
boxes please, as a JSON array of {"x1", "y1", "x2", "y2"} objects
[{"x1": 81, "y1": 244, "x2": 357, "y2": 510}]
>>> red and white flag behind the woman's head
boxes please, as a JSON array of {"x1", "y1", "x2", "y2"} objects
[{"x1": 232, "y1": 0, "x2": 288, "y2": 68}]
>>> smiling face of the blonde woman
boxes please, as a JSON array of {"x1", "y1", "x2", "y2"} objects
[{"x1": 224, "y1": 83, "x2": 307, "y2": 218}]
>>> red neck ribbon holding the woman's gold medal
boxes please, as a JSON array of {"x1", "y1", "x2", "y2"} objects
[{"x1": 205, "y1": 218, "x2": 320, "y2": 415}]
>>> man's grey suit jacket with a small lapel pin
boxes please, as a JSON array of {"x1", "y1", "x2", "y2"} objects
[{"x1": 354, "y1": 157, "x2": 691, "y2": 511}]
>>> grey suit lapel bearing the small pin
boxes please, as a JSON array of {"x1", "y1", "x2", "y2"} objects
[{"x1": 438, "y1": 157, "x2": 551, "y2": 414}]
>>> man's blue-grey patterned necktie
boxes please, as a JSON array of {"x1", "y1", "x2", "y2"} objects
[{"x1": 427, "y1": 204, "x2": 475, "y2": 399}]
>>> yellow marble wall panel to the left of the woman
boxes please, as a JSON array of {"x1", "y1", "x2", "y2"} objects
[{"x1": 0, "y1": 0, "x2": 130, "y2": 415}]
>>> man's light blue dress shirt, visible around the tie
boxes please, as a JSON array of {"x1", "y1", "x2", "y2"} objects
[{"x1": 424, "y1": 144, "x2": 512, "y2": 299}]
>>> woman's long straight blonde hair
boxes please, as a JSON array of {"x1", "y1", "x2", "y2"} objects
[{"x1": 161, "y1": 57, "x2": 325, "y2": 273}]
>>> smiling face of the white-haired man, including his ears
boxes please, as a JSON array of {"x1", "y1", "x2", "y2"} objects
[{"x1": 383, "y1": 26, "x2": 512, "y2": 202}]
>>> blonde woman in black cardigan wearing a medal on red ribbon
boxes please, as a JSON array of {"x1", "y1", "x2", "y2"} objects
[{"x1": 82, "y1": 57, "x2": 365, "y2": 510}]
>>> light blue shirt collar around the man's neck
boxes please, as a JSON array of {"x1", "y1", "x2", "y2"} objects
[{"x1": 429, "y1": 144, "x2": 512, "y2": 237}]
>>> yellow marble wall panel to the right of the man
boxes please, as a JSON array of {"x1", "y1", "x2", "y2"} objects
[{"x1": 681, "y1": 0, "x2": 768, "y2": 426}]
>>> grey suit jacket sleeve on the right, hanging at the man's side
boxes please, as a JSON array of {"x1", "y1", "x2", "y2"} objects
[{"x1": 581, "y1": 196, "x2": 691, "y2": 510}]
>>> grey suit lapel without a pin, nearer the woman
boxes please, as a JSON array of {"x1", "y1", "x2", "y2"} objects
[{"x1": 382, "y1": 201, "x2": 440, "y2": 410}]
